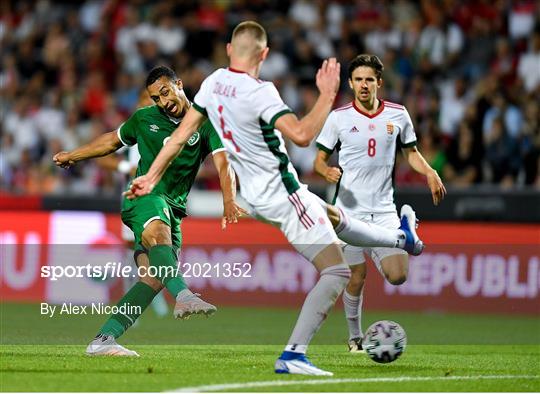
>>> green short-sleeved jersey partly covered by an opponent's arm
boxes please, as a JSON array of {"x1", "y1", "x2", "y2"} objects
[{"x1": 118, "y1": 105, "x2": 224, "y2": 216}]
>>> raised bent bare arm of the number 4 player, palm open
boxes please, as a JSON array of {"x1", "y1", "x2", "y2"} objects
[{"x1": 276, "y1": 58, "x2": 341, "y2": 146}]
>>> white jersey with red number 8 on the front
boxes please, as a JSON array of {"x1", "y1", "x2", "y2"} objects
[{"x1": 317, "y1": 100, "x2": 416, "y2": 215}]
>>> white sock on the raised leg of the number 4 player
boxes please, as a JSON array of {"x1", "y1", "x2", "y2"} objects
[{"x1": 335, "y1": 209, "x2": 405, "y2": 248}]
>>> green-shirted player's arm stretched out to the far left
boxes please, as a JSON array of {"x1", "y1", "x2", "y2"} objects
[{"x1": 53, "y1": 131, "x2": 122, "y2": 168}]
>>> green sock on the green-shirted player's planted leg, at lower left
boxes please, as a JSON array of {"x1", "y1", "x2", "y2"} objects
[{"x1": 99, "y1": 282, "x2": 159, "y2": 338}]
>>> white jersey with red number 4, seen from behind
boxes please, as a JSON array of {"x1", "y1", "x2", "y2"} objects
[{"x1": 193, "y1": 68, "x2": 300, "y2": 205}]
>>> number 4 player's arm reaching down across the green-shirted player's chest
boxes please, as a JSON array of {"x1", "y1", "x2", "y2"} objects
[{"x1": 124, "y1": 107, "x2": 206, "y2": 200}]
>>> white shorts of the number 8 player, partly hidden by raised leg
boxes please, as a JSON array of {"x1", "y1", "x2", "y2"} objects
[{"x1": 343, "y1": 213, "x2": 407, "y2": 271}]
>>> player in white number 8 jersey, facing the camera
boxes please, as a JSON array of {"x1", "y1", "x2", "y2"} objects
[{"x1": 314, "y1": 54, "x2": 446, "y2": 352}]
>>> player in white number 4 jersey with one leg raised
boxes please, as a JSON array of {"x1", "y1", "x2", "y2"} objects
[{"x1": 127, "y1": 21, "x2": 423, "y2": 375}]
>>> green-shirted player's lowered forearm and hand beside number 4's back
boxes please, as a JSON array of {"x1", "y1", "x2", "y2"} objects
[{"x1": 212, "y1": 152, "x2": 248, "y2": 229}]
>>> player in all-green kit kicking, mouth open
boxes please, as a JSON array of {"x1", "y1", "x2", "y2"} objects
[{"x1": 53, "y1": 66, "x2": 246, "y2": 356}]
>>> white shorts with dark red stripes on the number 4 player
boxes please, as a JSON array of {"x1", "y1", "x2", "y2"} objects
[{"x1": 249, "y1": 187, "x2": 340, "y2": 261}]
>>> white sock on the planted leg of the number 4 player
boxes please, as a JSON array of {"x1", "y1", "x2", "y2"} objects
[{"x1": 285, "y1": 263, "x2": 351, "y2": 353}]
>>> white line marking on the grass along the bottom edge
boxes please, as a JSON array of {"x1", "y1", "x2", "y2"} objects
[{"x1": 170, "y1": 375, "x2": 540, "y2": 393}]
